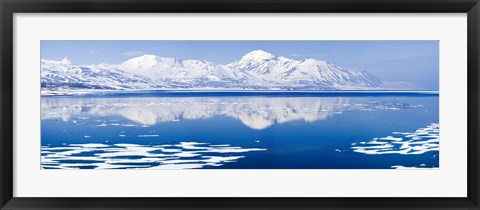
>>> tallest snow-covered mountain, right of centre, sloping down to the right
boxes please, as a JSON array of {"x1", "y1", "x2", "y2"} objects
[{"x1": 228, "y1": 50, "x2": 383, "y2": 89}]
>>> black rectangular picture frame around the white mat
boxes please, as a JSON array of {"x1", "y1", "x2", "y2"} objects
[{"x1": 0, "y1": 0, "x2": 480, "y2": 209}]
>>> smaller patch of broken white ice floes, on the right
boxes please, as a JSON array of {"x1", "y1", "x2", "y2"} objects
[{"x1": 351, "y1": 123, "x2": 440, "y2": 155}]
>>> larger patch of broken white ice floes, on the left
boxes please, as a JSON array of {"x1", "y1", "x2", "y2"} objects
[{"x1": 41, "y1": 142, "x2": 266, "y2": 169}]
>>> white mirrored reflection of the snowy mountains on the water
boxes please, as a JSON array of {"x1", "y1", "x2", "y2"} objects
[{"x1": 41, "y1": 97, "x2": 422, "y2": 130}]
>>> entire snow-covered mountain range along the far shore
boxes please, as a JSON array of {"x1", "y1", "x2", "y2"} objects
[{"x1": 41, "y1": 50, "x2": 384, "y2": 91}]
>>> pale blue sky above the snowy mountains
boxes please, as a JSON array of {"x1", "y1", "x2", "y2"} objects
[{"x1": 41, "y1": 40, "x2": 439, "y2": 90}]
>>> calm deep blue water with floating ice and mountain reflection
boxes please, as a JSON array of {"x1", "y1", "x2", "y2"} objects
[{"x1": 41, "y1": 92, "x2": 439, "y2": 169}]
